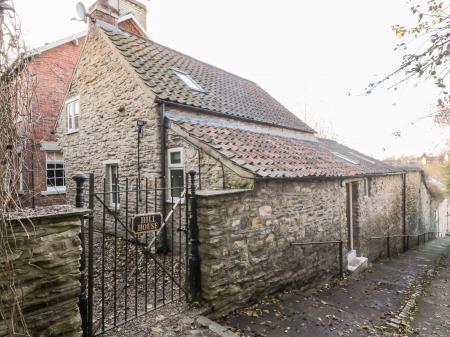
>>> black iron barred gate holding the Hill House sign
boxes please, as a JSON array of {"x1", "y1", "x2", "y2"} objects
[{"x1": 73, "y1": 171, "x2": 200, "y2": 337}]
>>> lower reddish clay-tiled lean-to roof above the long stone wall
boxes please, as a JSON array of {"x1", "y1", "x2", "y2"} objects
[{"x1": 171, "y1": 119, "x2": 401, "y2": 178}]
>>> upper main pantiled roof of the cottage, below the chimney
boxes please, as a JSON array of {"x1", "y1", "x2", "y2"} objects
[{"x1": 104, "y1": 30, "x2": 314, "y2": 133}]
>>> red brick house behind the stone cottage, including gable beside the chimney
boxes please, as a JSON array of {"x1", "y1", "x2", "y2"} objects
[{"x1": 20, "y1": 0, "x2": 147, "y2": 207}]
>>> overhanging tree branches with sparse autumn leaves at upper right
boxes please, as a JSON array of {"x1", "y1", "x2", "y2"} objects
[{"x1": 366, "y1": 0, "x2": 450, "y2": 124}]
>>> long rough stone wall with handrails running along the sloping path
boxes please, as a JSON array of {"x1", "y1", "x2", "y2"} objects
[{"x1": 198, "y1": 174, "x2": 434, "y2": 314}]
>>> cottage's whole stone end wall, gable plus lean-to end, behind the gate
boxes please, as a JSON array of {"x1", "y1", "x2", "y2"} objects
[{"x1": 56, "y1": 27, "x2": 253, "y2": 232}]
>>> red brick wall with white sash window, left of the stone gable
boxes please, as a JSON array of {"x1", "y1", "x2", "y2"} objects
[{"x1": 20, "y1": 32, "x2": 86, "y2": 206}]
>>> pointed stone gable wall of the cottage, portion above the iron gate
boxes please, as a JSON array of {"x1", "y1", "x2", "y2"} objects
[{"x1": 56, "y1": 27, "x2": 161, "y2": 203}]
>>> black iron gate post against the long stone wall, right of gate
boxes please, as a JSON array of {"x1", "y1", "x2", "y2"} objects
[{"x1": 189, "y1": 170, "x2": 201, "y2": 302}]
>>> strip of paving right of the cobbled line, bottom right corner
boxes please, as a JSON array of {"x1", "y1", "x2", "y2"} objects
[{"x1": 413, "y1": 244, "x2": 450, "y2": 337}]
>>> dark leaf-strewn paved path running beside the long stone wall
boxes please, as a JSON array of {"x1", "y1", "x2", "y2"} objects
[{"x1": 221, "y1": 238, "x2": 450, "y2": 337}]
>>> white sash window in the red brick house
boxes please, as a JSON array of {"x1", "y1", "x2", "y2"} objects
[{"x1": 45, "y1": 151, "x2": 66, "y2": 193}]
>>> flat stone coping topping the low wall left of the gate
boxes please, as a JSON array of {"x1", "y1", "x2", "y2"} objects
[{"x1": 6, "y1": 205, "x2": 90, "y2": 221}]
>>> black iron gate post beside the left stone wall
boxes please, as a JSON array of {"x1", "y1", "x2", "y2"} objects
[{"x1": 72, "y1": 172, "x2": 89, "y2": 337}]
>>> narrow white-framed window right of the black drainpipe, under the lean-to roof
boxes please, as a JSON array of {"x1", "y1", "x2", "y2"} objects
[{"x1": 167, "y1": 147, "x2": 184, "y2": 201}]
